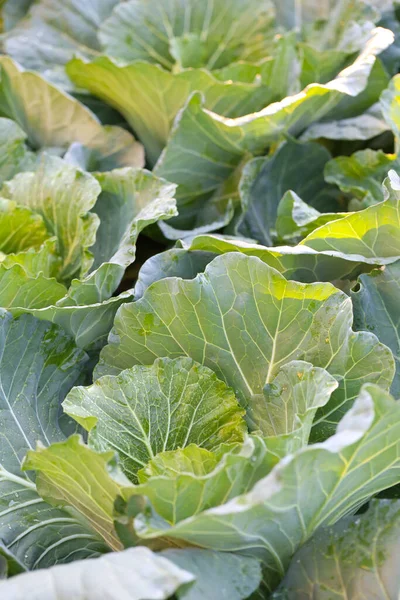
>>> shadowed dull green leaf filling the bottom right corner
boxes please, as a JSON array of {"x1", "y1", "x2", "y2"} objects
[{"x1": 276, "y1": 500, "x2": 400, "y2": 600}]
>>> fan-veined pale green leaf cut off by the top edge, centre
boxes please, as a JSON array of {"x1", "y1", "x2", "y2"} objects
[{"x1": 99, "y1": 0, "x2": 274, "y2": 69}]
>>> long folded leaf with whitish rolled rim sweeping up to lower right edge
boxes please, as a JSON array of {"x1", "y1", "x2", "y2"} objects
[{"x1": 134, "y1": 385, "x2": 400, "y2": 589}]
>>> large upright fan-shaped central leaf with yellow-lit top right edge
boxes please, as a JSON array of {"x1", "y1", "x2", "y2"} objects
[{"x1": 97, "y1": 253, "x2": 394, "y2": 435}]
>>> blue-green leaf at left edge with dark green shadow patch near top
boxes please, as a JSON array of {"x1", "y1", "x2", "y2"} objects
[{"x1": 0, "y1": 310, "x2": 87, "y2": 474}]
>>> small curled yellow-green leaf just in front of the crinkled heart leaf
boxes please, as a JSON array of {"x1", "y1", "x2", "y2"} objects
[{"x1": 118, "y1": 436, "x2": 274, "y2": 524}]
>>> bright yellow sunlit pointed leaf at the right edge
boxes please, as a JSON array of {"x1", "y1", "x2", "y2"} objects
[{"x1": 300, "y1": 171, "x2": 400, "y2": 264}]
